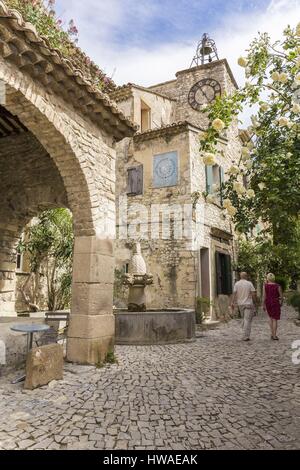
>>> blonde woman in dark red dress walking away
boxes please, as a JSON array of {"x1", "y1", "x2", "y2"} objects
[{"x1": 263, "y1": 273, "x2": 283, "y2": 340}]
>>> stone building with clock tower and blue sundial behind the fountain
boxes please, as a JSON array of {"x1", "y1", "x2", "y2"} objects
[{"x1": 112, "y1": 60, "x2": 241, "y2": 316}]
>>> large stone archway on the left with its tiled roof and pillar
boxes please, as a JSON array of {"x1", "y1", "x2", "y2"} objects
[{"x1": 0, "y1": 2, "x2": 134, "y2": 364}]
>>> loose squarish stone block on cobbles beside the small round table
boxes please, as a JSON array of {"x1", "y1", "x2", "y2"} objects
[{"x1": 24, "y1": 344, "x2": 64, "y2": 390}]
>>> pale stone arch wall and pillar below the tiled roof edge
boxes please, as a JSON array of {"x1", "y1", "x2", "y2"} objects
[{"x1": 0, "y1": 49, "x2": 130, "y2": 363}]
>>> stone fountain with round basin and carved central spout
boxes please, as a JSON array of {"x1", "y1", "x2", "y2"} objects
[{"x1": 115, "y1": 243, "x2": 195, "y2": 345}]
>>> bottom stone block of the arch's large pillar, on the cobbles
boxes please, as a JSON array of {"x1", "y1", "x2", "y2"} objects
[{"x1": 67, "y1": 335, "x2": 114, "y2": 364}]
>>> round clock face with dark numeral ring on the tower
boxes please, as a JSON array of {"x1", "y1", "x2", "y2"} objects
[{"x1": 189, "y1": 78, "x2": 221, "y2": 111}]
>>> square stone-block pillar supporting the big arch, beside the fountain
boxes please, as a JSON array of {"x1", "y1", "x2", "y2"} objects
[{"x1": 67, "y1": 236, "x2": 115, "y2": 364}]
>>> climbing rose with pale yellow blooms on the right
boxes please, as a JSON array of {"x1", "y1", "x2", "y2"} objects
[{"x1": 195, "y1": 24, "x2": 300, "y2": 242}]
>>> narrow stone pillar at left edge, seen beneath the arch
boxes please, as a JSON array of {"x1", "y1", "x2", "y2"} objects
[{"x1": 0, "y1": 223, "x2": 19, "y2": 317}]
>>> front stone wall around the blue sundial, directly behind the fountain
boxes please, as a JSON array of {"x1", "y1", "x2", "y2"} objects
[{"x1": 115, "y1": 130, "x2": 195, "y2": 308}]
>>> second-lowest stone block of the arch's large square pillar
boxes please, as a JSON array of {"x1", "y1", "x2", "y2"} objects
[{"x1": 68, "y1": 313, "x2": 115, "y2": 339}]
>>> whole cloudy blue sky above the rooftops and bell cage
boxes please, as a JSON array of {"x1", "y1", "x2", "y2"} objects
[{"x1": 56, "y1": 0, "x2": 300, "y2": 86}]
